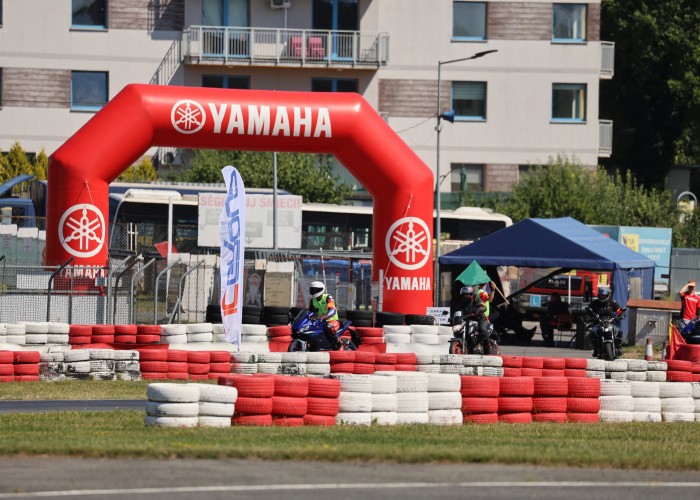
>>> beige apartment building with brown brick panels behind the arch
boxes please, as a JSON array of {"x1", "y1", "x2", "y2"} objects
[{"x1": 0, "y1": 0, "x2": 614, "y2": 195}]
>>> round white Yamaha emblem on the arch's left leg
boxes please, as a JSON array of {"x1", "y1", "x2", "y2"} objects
[{"x1": 58, "y1": 203, "x2": 107, "y2": 258}]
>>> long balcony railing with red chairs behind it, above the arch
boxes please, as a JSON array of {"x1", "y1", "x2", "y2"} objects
[{"x1": 183, "y1": 26, "x2": 389, "y2": 67}]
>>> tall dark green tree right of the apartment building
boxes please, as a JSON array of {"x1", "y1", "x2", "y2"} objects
[{"x1": 601, "y1": 0, "x2": 700, "y2": 187}]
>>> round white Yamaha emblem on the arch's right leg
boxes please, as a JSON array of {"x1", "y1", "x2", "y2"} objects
[{"x1": 386, "y1": 217, "x2": 431, "y2": 271}]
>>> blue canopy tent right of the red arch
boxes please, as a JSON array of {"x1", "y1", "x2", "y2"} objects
[{"x1": 440, "y1": 217, "x2": 654, "y2": 338}]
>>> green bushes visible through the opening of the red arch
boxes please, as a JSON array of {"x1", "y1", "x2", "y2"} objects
[{"x1": 179, "y1": 149, "x2": 352, "y2": 203}]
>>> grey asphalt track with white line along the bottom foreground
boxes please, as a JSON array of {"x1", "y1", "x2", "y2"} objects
[{"x1": 0, "y1": 457, "x2": 700, "y2": 500}]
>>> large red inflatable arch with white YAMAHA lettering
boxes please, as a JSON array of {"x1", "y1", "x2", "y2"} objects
[{"x1": 45, "y1": 85, "x2": 433, "y2": 314}]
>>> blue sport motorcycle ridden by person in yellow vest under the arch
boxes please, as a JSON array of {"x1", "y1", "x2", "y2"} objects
[{"x1": 287, "y1": 309, "x2": 359, "y2": 352}]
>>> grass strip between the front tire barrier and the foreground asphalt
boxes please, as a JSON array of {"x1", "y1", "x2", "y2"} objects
[{"x1": 0, "y1": 411, "x2": 700, "y2": 470}]
